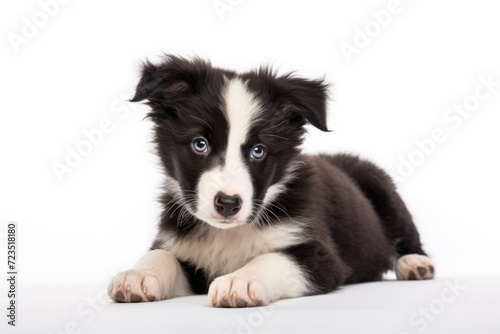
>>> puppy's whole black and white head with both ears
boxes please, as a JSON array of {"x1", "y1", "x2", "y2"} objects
[{"x1": 131, "y1": 56, "x2": 327, "y2": 229}]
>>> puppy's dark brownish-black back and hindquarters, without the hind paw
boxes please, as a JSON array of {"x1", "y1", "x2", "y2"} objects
[{"x1": 304, "y1": 154, "x2": 425, "y2": 283}]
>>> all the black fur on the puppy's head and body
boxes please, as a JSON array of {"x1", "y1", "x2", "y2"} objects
[{"x1": 132, "y1": 56, "x2": 425, "y2": 294}]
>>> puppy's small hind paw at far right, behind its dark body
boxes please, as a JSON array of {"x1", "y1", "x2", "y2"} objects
[{"x1": 396, "y1": 254, "x2": 434, "y2": 280}]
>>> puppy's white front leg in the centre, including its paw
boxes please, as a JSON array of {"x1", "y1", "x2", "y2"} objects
[{"x1": 208, "y1": 253, "x2": 309, "y2": 307}]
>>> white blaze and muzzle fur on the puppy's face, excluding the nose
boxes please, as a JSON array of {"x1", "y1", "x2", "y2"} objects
[{"x1": 196, "y1": 78, "x2": 262, "y2": 228}]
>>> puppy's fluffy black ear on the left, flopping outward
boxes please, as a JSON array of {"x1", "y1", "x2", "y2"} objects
[{"x1": 130, "y1": 55, "x2": 211, "y2": 107}]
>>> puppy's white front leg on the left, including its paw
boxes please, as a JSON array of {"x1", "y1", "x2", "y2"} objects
[{"x1": 108, "y1": 249, "x2": 190, "y2": 303}]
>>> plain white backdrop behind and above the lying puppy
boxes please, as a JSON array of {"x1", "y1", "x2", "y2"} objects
[{"x1": 0, "y1": 0, "x2": 500, "y2": 286}]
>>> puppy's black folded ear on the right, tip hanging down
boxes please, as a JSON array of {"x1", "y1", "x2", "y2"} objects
[{"x1": 276, "y1": 74, "x2": 330, "y2": 132}]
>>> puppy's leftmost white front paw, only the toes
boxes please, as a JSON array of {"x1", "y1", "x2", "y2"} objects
[{"x1": 108, "y1": 269, "x2": 162, "y2": 303}]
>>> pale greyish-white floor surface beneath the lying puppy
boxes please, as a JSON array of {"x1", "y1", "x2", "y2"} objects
[{"x1": 4, "y1": 278, "x2": 500, "y2": 334}]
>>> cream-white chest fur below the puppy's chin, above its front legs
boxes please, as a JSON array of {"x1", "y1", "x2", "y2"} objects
[{"x1": 162, "y1": 222, "x2": 307, "y2": 277}]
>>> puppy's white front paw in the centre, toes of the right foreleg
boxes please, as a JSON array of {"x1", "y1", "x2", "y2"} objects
[{"x1": 208, "y1": 273, "x2": 271, "y2": 307}]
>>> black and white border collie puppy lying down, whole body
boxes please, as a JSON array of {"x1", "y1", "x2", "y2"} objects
[{"x1": 109, "y1": 56, "x2": 434, "y2": 307}]
